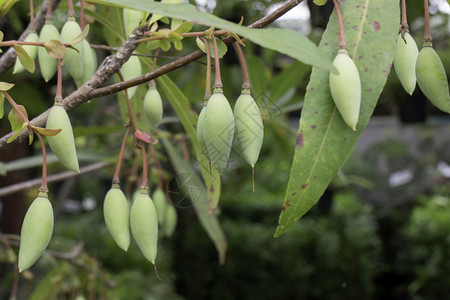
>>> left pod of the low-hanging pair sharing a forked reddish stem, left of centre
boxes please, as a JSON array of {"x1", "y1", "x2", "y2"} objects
[{"x1": 103, "y1": 184, "x2": 130, "y2": 251}]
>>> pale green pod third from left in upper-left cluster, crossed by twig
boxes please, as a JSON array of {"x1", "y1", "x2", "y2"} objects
[{"x1": 61, "y1": 17, "x2": 84, "y2": 86}]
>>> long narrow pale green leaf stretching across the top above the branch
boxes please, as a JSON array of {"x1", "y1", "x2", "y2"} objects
[{"x1": 91, "y1": 0, "x2": 332, "y2": 70}]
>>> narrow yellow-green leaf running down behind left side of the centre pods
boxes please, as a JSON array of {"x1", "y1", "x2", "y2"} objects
[{"x1": 156, "y1": 75, "x2": 220, "y2": 211}]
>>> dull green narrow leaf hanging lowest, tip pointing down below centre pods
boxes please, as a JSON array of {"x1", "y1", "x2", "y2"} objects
[{"x1": 162, "y1": 137, "x2": 227, "y2": 264}]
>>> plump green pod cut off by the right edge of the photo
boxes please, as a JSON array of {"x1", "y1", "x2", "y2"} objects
[{"x1": 416, "y1": 46, "x2": 450, "y2": 113}]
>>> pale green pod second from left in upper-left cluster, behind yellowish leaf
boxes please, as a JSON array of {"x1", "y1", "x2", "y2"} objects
[{"x1": 38, "y1": 21, "x2": 59, "y2": 82}]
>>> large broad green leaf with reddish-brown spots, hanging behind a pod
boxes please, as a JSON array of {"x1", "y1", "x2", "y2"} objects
[{"x1": 275, "y1": 0, "x2": 400, "y2": 237}]
